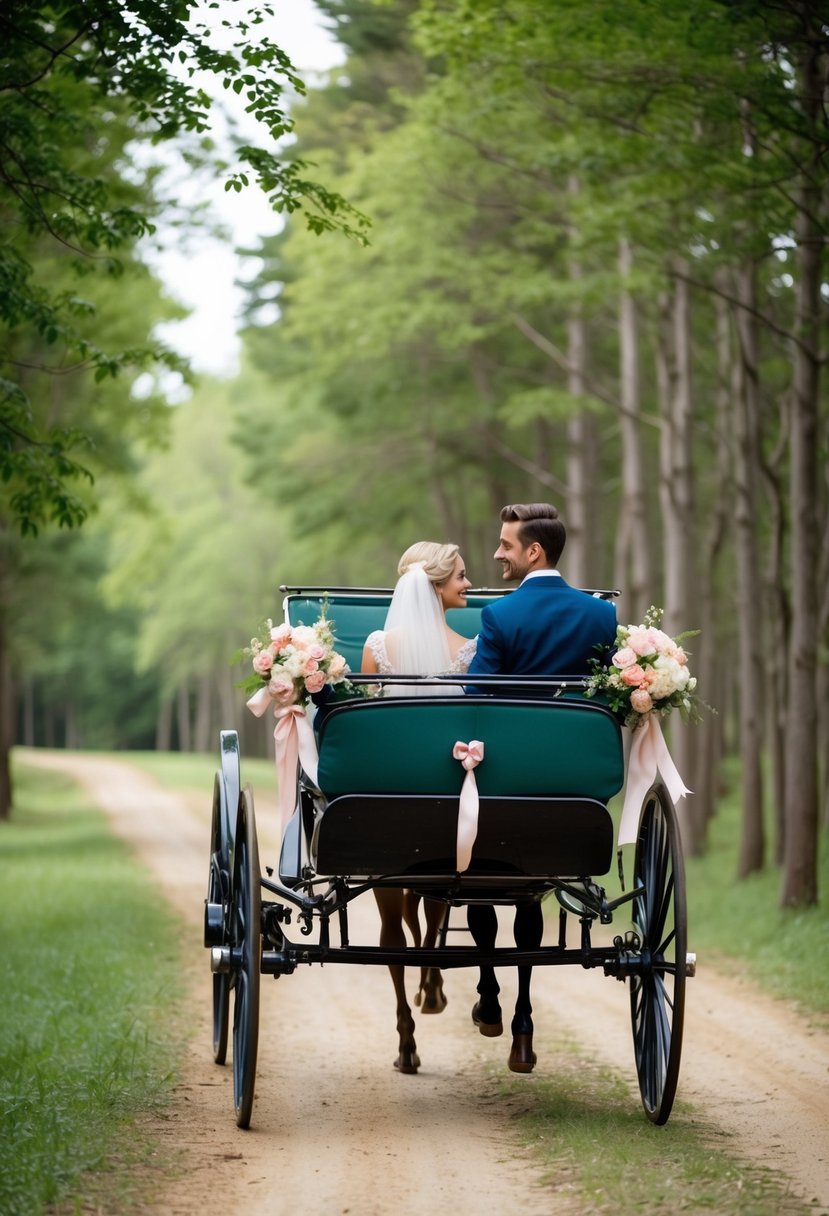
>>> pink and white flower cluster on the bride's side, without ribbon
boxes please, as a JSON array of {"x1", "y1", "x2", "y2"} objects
[{"x1": 242, "y1": 615, "x2": 349, "y2": 705}]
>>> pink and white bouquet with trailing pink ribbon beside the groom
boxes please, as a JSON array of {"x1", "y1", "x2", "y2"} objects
[{"x1": 585, "y1": 607, "x2": 699, "y2": 845}]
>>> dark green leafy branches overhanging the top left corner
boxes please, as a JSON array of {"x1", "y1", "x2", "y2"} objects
[{"x1": 0, "y1": 0, "x2": 366, "y2": 533}]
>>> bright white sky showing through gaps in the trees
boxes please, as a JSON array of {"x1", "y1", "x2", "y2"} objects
[{"x1": 145, "y1": 0, "x2": 344, "y2": 381}]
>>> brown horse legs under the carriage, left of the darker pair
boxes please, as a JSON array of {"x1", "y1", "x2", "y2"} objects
[{"x1": 374, "y1": 886, "x2": 447, "y2": 1073}]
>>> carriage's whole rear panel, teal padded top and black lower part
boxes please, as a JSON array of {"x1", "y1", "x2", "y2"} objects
[{"x1": 310, "y1": 696, "x2": 624, "y2": 889}]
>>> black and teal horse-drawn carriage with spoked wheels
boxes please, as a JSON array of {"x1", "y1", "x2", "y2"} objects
[{"x1": 204, "y1": 586, "x2": 695, "y2": 1127}]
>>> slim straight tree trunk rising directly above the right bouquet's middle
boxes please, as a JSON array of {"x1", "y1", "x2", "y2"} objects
[{"x1": 615, "y1": 240, "x2": 652, "y2": 620}]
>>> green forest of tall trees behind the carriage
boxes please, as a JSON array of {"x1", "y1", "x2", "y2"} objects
[{"x1": 0, "y1": 0, "x2": 829, "y2": 906}]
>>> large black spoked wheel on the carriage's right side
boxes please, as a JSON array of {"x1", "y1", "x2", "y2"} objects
[{"x1": 631, "y1": 781, "x2": 687, "y2": 1124}]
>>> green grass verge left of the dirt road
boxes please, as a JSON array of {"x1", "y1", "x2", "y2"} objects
[{"x1": 0, "y1": 764, "x2": 180, "y2": 1216}]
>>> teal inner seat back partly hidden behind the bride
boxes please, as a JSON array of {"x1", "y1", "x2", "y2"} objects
[{"x1": 286, "y1": 592, "x2": 483, "y2": 671}]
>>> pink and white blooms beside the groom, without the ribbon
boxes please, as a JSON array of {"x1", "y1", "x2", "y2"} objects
[{"x1": 586, "y1": 607, "x2": 699, "y2": 726}]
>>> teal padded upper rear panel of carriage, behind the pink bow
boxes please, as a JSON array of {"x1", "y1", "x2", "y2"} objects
[{"x1": 318, "y1": 697, "x2": 625, "y2": 803}]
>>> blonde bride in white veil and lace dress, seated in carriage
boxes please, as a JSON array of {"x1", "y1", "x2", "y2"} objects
[{"x1": 362, "y1": 540, "x2": 475, "y2": 697}]
